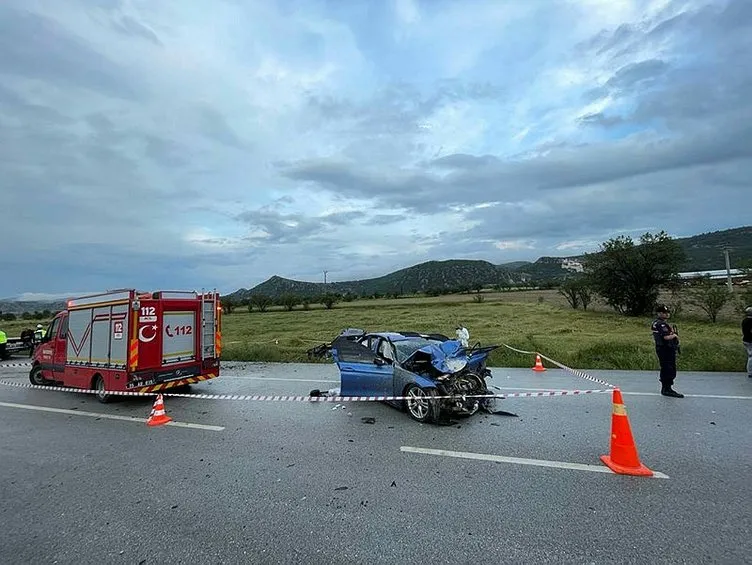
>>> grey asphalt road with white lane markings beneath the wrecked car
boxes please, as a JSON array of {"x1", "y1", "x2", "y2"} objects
[{"x1": 0, "y1": 363, "x2": 752, "y2": 564}]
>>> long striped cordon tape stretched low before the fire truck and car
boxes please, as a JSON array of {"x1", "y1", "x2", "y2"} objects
[{"x1": 0, "y1": 381, "x2": 611, "y2": 402}]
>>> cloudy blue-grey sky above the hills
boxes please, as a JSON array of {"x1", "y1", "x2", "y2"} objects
[{"x1": 0, "y1": 0, "x2": 752, "y2": 297}]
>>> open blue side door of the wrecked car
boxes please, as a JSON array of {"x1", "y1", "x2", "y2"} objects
[{"x1": 332, "y1": 338, "x2": 394, "y2": 396}]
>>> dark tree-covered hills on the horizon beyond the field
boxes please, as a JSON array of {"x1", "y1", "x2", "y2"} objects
[{"x1": 228, "y1": 226, "x2": 752, "y2": 301}]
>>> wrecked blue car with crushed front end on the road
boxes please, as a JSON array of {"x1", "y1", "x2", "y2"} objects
[{"x1": 308, "y1": 328, "x2": 506, "y2": 423}]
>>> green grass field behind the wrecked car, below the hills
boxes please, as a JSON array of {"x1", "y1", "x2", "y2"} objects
[{"x1": 3, "y1": 291, "x2": 746, "y2": 371}]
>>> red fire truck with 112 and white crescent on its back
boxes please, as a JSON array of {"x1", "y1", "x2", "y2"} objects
[{"x1": 29, "y1": 289, "x2": 222, "y2": 402}]
